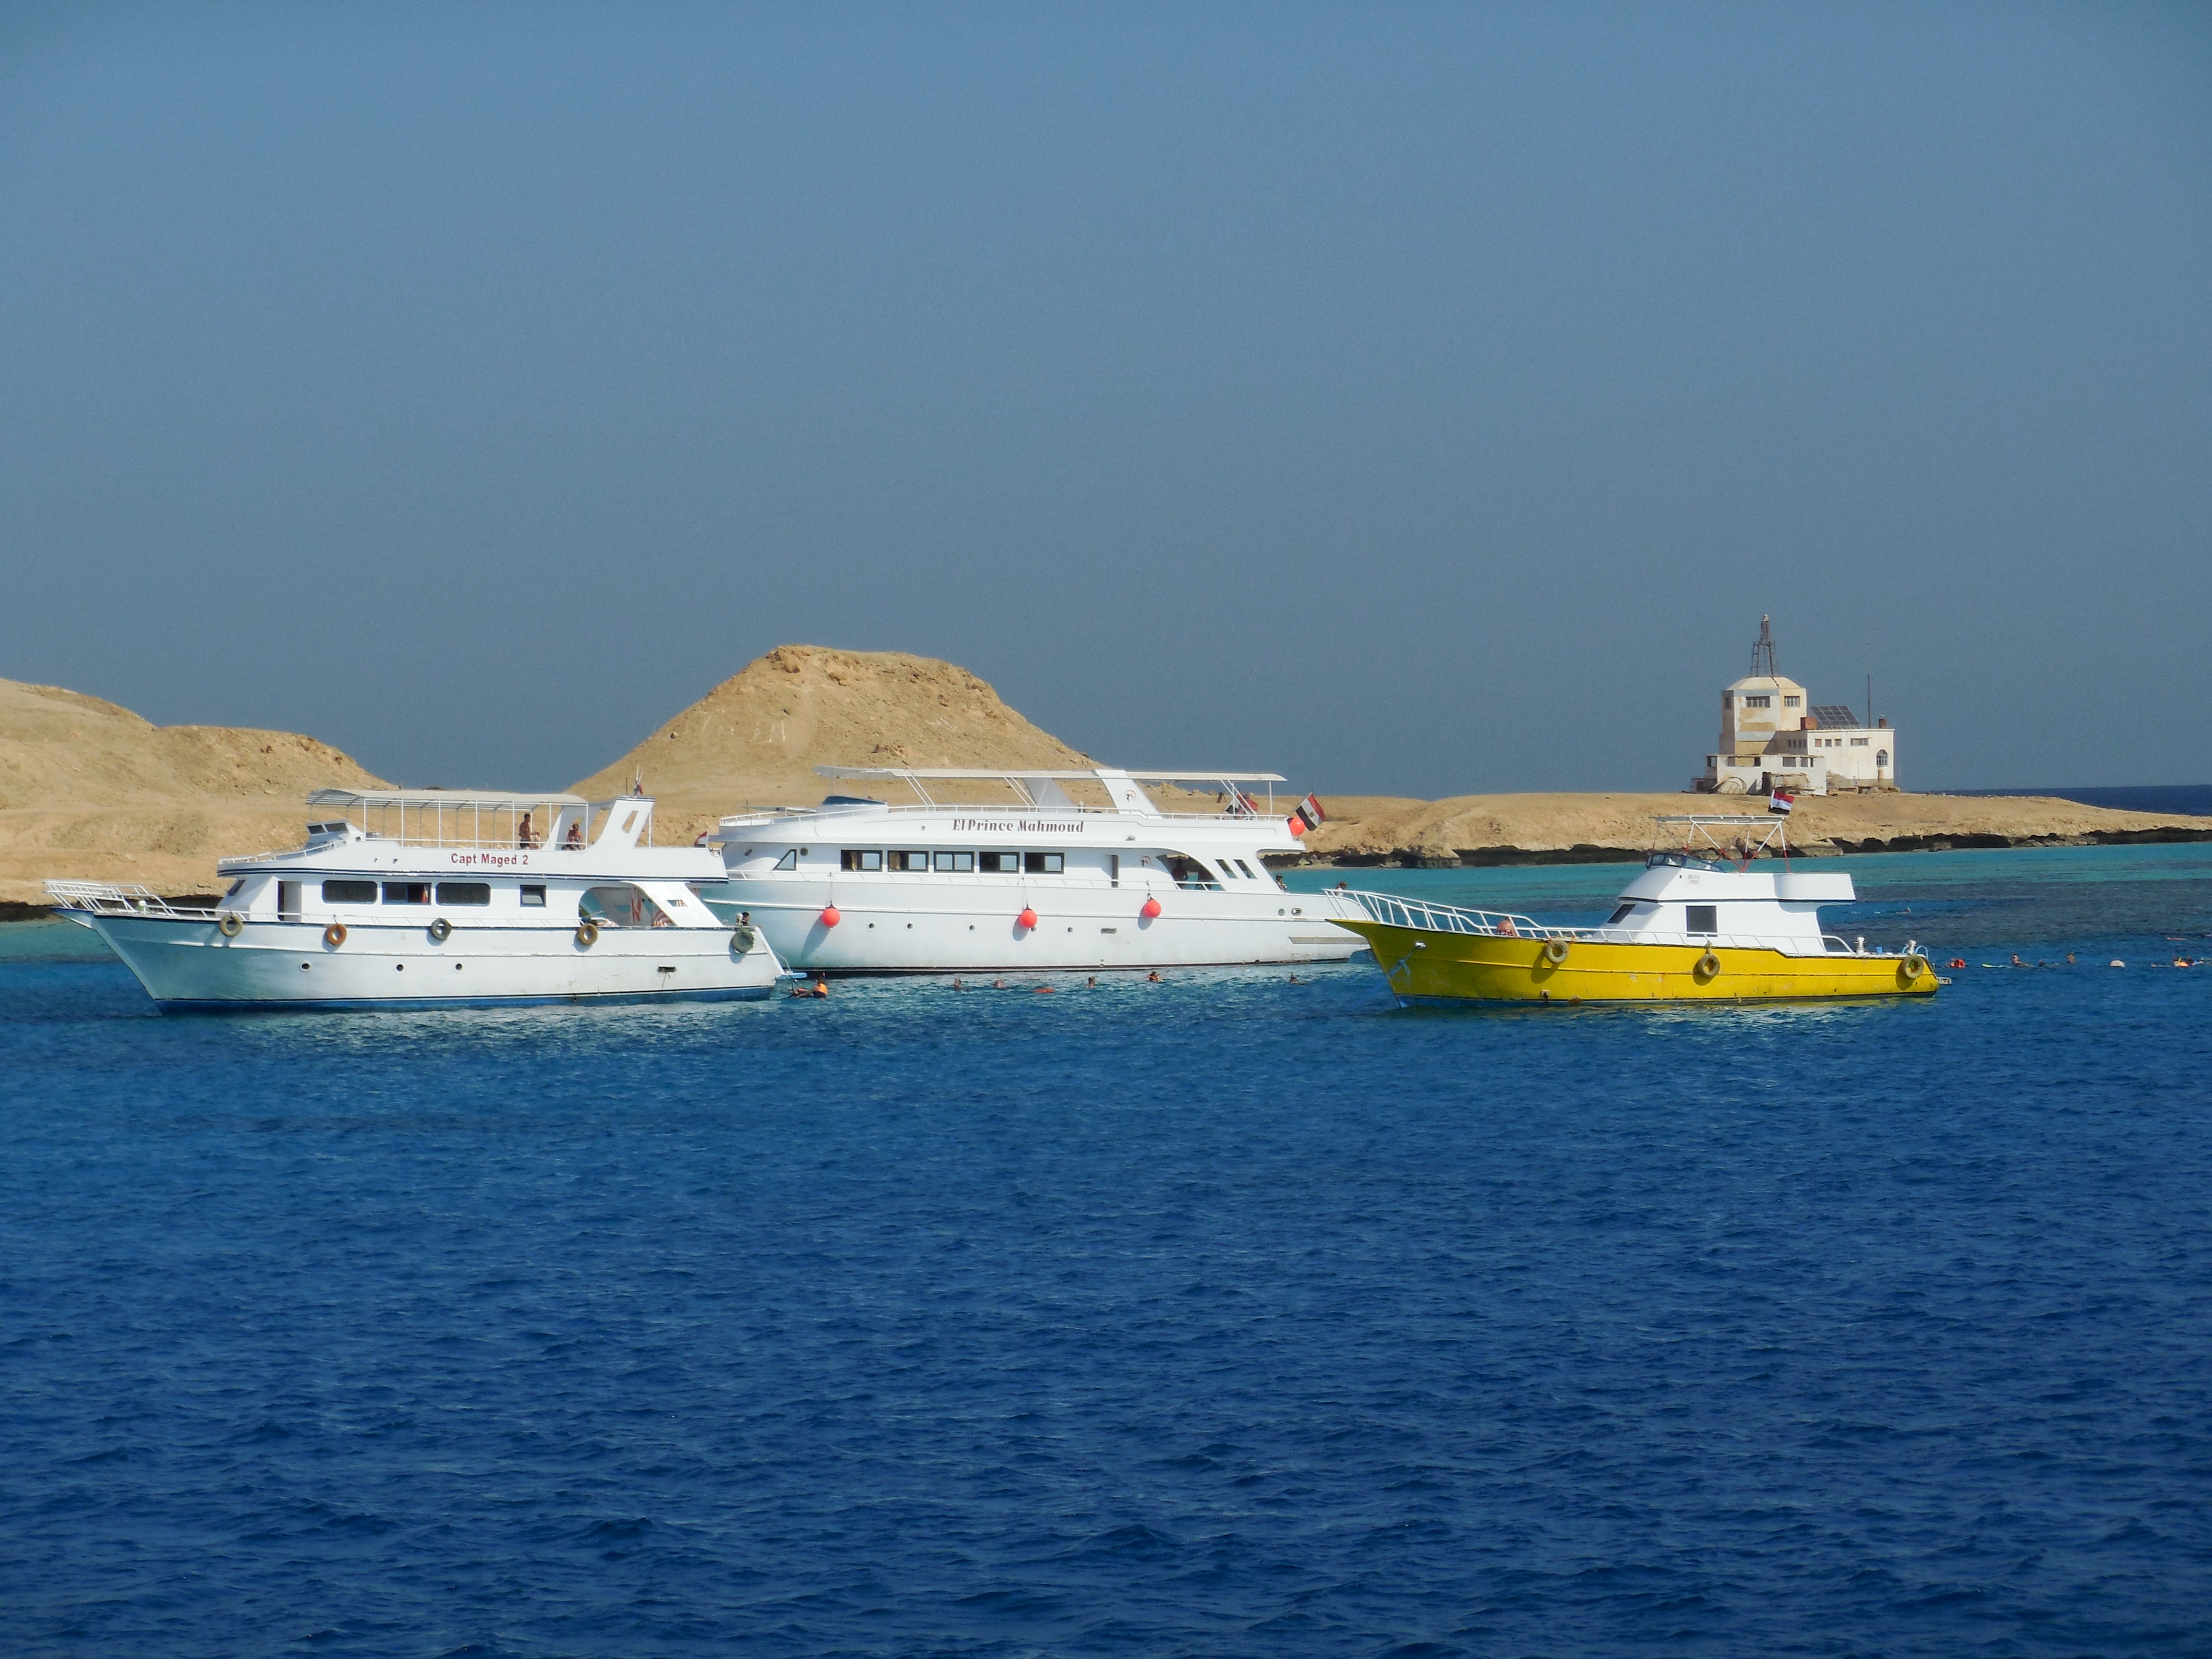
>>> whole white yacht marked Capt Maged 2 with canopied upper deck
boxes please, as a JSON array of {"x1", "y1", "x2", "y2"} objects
[{"x1": 47, "y1": 790, "x2": 785, "y2": 1009}]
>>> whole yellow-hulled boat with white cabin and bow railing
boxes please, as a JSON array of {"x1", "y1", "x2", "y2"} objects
[{"x1": 1336, "y1": 814, "x2": 1942, "y2": 1004}]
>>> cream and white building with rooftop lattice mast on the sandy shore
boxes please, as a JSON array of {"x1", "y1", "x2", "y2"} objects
[{"x1": 1692, "y1": 617, "x2": 1898, "y2": 794}]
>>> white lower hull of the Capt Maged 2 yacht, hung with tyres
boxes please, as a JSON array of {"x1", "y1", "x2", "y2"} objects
[{"x1": 64, "y1": 911, "x2": 783, "y2": 1011}]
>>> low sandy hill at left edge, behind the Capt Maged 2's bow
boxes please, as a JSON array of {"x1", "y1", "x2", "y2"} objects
[{"x1": 0, "y1": 679, "x2": 381, "y2": 902}]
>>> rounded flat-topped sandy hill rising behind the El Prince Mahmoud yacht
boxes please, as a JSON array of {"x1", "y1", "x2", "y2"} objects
[{"x1": 571, "y1": 646, "x2": 1093, "y2": 841}]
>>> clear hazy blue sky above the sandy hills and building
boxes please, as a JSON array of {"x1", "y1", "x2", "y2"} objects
[{"x1": 0, "y1": 4, "x2": 2212, "y2": 794}]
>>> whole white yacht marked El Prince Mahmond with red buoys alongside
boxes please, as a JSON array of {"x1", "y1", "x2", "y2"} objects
[{"x1": 712, "y1": 765, "x2": 1367, "y2": 974}]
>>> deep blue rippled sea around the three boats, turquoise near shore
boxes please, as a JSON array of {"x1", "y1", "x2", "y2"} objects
[{"x1": 0, "y1": 847, "x2": 2212, "y2": 1659}]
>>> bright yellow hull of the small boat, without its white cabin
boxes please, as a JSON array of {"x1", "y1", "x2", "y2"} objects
[{"x1": 1340, "y1": 920, "x2": 1938, "y2": 1002}]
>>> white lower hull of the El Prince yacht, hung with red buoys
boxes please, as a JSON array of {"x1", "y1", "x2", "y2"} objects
[{"x1": 701, "y1": 878, "x2": 1365, "y2": 974}]
